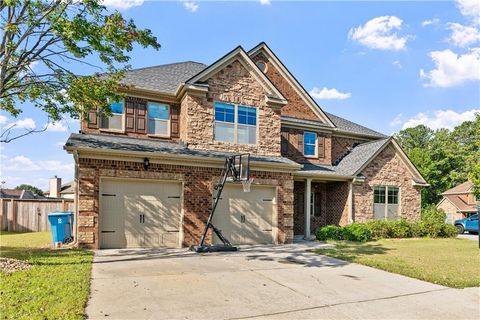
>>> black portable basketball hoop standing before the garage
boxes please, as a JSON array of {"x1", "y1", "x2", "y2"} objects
[{"x1": 190, "y1": 155, "x2": 250, "y2": 252}]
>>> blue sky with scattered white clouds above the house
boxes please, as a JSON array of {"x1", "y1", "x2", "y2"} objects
[{"x1": 0, "y1": 0, "x2": 480, "y2": 189}]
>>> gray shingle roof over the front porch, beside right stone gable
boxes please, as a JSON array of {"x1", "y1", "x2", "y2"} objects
[{"x1": 302, "y1": 138, "x2": 391, "y2": 176}]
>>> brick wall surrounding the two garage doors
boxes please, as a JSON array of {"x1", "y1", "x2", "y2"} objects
[{"x1": 78, "y1": 158, "x2": 293, "y2": 249}]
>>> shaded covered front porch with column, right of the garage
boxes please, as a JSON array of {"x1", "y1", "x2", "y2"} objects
[{"x1": 293, "y1": 177, "x2": 353, "y2": 239}]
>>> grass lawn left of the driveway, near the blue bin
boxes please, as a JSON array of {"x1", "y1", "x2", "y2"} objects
[{"x1": 0, "y1": 232, "x2": 93, "y2": 319}]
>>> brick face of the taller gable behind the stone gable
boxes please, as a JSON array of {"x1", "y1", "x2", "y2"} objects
[{"x1": 252, "y1": 53, "x2": 320, "y2": 121}]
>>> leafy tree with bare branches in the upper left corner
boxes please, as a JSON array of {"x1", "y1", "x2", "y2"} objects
[{"x1": 0, "y1": 0, "x2": 160, "y2": 142}]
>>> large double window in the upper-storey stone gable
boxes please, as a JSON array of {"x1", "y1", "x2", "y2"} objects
[{"x1": 214, "y1": 102, "x2": 257, "y2": 144}]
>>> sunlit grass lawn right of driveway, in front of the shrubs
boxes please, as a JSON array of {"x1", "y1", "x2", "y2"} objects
[{"x1": 315, "y1": 239, "x2": 480, "y2": 288}]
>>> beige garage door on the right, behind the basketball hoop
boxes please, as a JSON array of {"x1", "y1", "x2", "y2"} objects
[{"x1": 213, "y1": 185, "x2": 276, "y2": 244}]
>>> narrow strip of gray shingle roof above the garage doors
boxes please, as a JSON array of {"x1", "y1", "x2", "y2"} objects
[{"x1": 65, "y1": 133, "x2": 298, "y2": 166}]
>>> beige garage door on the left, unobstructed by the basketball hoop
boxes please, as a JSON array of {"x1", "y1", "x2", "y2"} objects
[{"x1": 100, "y1": 179, "x2": 182, "y2": 248}]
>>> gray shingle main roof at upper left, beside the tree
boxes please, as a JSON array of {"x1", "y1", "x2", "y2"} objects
[{"x1": 121, "y1": 61, "x2": 207, "y2": 94}]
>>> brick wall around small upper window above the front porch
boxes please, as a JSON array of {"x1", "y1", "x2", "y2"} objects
[{"x1": 282, "y1": 128, "x2": 332, "y2": 165}]
